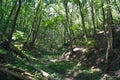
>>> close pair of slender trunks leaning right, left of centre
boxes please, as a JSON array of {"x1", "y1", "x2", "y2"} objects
[{"x1": 24, "y1": 0, "x2": 42, "y2": 47}]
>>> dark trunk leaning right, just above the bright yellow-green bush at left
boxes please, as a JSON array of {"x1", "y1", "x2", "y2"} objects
[{"x1": 8, "y1": 0, "x2": 21, "y2": 43}]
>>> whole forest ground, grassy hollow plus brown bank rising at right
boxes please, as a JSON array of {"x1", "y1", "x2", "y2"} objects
[{"x1": 0, "y1": 30, "x2": 119, "y2": 80}]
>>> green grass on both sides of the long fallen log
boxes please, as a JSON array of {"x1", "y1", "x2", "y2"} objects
[{"x1": 1, "y1": 45, "x2": 111, "y2": 80}]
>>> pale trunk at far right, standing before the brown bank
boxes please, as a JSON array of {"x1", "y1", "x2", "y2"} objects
[{"x1": 106, "y1": 0, "x2": 113, "y2": 62}]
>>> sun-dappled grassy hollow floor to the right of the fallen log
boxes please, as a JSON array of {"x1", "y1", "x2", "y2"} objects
[{"x1": 19, "y1": 48, "x2": 104, "y2": 80}]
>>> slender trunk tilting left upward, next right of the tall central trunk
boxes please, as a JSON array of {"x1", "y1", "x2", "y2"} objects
[{"x1": 78, "y1": 0, "x2": 87, "y2": 39}]
